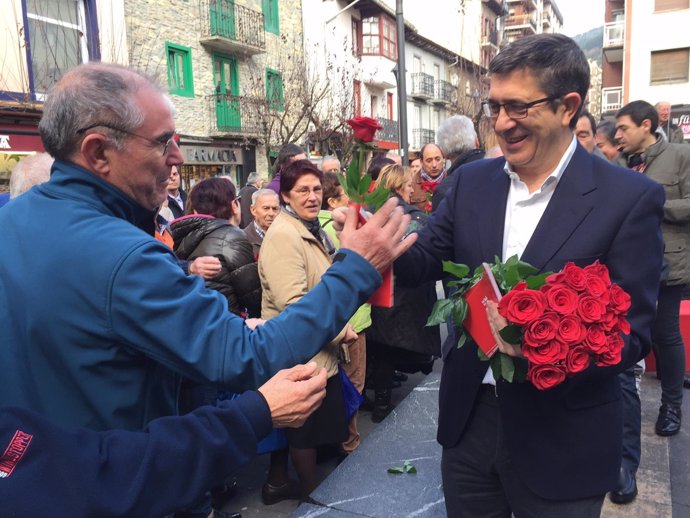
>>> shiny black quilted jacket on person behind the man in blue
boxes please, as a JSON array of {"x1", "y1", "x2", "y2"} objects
[{"x1": 171, "y1": 214, "x2": 261, "y2": 318}]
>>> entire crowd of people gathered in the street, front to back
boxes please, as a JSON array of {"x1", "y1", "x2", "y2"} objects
[{"x1": 0, "y1": 34, "x2": 690, "y2": 518}]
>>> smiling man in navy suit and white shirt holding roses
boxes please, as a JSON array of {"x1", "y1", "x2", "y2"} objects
[{"x1": 395, "y1": 34, "x2": 664, "y2": 518}]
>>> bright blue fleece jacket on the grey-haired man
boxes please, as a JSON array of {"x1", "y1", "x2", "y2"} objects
[{"x1": 0, "y1": 161, "x2": 381, "y2": 430}]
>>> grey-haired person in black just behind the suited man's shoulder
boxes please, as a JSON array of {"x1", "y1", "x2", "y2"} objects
[{"x1": 431, "y1": 115, "x2": 484, "y2": 211}]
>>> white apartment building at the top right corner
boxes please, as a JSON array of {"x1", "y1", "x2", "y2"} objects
[{"x1": 602, "y1": 0, "x2": 690, "y2": 140}]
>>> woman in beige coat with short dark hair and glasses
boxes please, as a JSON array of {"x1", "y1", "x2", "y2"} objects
[{"x1": 259, "y1": 160, "x2": 357, "y2": 503}]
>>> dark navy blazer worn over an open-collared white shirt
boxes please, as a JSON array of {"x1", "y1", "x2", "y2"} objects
[{"x1": 395, "y1": 144, "x2": 664, "y2": 500}]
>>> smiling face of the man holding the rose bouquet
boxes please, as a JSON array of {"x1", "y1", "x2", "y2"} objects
[{"x1": 489, "y1": 69, "x2": 580, "y2": 181}]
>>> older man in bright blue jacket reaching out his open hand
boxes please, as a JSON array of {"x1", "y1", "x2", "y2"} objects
[{"x1": 0, "y1": 63, "x2": 414, "y2": 512}]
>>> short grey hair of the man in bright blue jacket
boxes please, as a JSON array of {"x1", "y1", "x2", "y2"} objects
[{"x1": 38, "y1": 63, "x2": 164, "y2": 160}]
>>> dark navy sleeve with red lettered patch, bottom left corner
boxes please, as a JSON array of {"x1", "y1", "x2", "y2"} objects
[{"x1": 0, "y1": 392, "x2": 271, "y2": 518}]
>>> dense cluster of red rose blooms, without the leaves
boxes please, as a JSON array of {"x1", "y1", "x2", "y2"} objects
[{"x1": 498, "y1": 261, "x2": 630, "y2": 390}]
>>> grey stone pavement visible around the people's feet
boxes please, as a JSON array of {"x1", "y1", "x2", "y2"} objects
[{"x1": 224, "y1": 370, "x2": 690, "y2": 518}]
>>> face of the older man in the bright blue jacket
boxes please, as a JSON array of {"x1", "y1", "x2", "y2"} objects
[{"x1": 105, "y1": 87, "x2": 184, "y2": 210}]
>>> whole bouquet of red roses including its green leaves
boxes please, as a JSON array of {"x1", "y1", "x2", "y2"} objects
[{"x1": 427, "y1": 256, "x2": 630, "y2": 390}]
